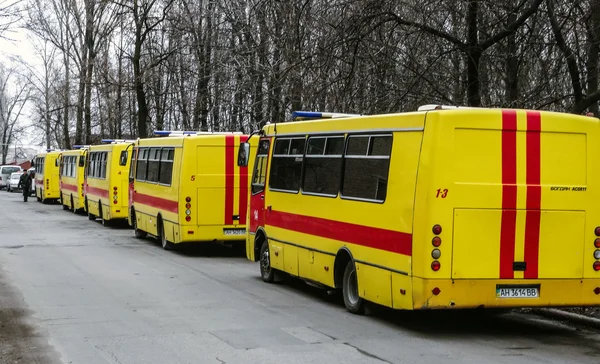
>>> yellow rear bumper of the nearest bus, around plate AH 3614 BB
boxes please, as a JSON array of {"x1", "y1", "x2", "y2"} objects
[{"x1": 413, "y1": 277, "x2": 600, "y2": 310}]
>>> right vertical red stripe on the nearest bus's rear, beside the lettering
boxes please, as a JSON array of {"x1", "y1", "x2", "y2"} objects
[{"x1": 524, "y1": 111, "x2": 542, "y2": 279}]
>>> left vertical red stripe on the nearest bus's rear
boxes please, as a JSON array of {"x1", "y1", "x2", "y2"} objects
[{"x1": 500, "y1": 110, "x2": 517, "y2": 279}]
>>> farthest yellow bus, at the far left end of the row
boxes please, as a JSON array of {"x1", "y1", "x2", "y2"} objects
[{"x1": 34, "y1": 150, "x2": 61, "y2": 203}]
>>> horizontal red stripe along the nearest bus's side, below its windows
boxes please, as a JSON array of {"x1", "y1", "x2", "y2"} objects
[{"x1": 266, "y1": 211, "x2": 412, "y2": 256}]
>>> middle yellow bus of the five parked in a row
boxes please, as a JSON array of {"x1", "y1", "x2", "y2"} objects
[{"x1": 84, "y1": 139, "x2": 133, "y2": 226}]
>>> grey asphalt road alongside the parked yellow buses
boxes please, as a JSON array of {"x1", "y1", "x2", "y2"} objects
[{"x1": 0, "y1": 191, "x2": 600, "y2": 364}]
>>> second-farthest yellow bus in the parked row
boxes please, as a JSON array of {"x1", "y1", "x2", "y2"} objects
[{"x1": 59, "y1": 146, "x2": 87, "y2": 213}]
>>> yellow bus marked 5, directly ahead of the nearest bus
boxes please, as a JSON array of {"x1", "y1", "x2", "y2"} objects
[{"x1": 129, "y1": 131, "x2": 255, "y2": 251}]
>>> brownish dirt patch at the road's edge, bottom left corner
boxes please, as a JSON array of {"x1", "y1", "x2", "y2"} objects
[{"x1": 0, "y1": 269, "x2": 60, "y2": 364}]
